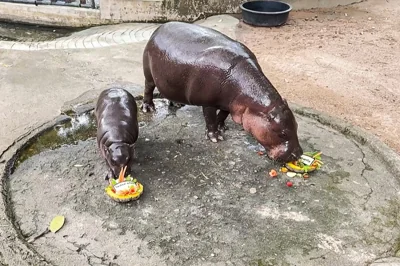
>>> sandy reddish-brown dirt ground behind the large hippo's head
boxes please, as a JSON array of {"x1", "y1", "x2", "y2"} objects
[{"x1": 237, "y1": 1, "x2": 400, "y2": 152}]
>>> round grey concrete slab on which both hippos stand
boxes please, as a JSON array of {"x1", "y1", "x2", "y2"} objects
[{"x1": 9, "y1": 100, "x2": 400, "y2": 266}]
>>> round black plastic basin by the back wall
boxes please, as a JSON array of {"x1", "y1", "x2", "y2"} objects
[{"x1": 240, "y1": 1, "x2": 292, "y2": 27}]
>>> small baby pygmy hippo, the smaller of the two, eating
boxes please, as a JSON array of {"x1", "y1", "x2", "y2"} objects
[{"x1": 95, "y1": 88, "x2": 139, "y2": 179}]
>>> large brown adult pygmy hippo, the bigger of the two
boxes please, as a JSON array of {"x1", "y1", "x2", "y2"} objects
[{"x1": 142, "y1": 22, "x2": 303, "y2": 162}]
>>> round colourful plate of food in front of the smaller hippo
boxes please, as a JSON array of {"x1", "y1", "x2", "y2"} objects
[{"x1": 105, "y1": 166, "x2": 143, "y2": 202}]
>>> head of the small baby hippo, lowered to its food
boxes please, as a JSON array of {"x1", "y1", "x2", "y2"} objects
[{"x1": 104, "y1": 143, "x2": 135, "y2": 179}]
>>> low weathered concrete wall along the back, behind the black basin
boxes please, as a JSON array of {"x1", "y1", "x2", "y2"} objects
[{"x1": 0, "y1": 0, "x2": 362, "y2": 27}]
